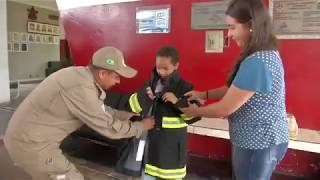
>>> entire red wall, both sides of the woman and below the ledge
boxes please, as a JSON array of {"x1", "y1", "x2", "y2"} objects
[{"x1": 61, "y1": 0, "x2": 320, "y2": 177}]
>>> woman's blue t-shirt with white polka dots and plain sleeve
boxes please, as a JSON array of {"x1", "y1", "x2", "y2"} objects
[{"x1": 229, "y1": 51, "x2": 289, "y2": 149}]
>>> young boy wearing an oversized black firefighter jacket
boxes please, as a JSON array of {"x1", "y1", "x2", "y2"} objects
[{"x1": 129, "y1": 46, "x2": 200, "y2": 180}]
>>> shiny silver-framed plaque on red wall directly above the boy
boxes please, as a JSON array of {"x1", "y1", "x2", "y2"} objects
[{"x1": 136, "y1": 5, "x2": 171, "y2": 34}]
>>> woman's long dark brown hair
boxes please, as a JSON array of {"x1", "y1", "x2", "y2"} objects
[{"x1": 226, "y1": 0, "x2": 277, "y2": 86}]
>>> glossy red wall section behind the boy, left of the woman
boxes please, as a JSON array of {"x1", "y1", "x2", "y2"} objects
[{"x1": 62, "y1": 0, "x2": 238, "y2": 95}]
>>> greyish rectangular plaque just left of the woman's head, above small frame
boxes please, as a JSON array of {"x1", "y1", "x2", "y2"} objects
[{"x1": 191, "y1": 0, "x2": 229, "y2": 29}]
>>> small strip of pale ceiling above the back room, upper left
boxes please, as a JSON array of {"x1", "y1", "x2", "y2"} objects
[{"x1": 8, "y1": 0, "x2": 58, "y2": 11}]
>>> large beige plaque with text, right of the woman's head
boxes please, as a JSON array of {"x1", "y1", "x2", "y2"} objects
[{"x1": 269, "y1": 0, "x2": 320, "y2": 39}]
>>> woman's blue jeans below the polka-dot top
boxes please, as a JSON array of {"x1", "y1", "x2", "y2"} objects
[{"x1": 232, "y1": 143, "x2": 288, "y2": 180}]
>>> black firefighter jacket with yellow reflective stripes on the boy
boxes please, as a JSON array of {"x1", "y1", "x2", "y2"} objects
[{"x1": 129, "y1": 70, "x2": 200, "y2": 179}]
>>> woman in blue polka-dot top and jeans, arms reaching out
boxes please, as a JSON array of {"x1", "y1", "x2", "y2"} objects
[{"x1": 181, "y1": 0, "x2": 289, "y2": 180}]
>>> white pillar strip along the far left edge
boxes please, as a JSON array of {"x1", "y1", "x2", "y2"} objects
[{"x1": 0, "y1": 0, "x2": 10, "y2": 103}]
